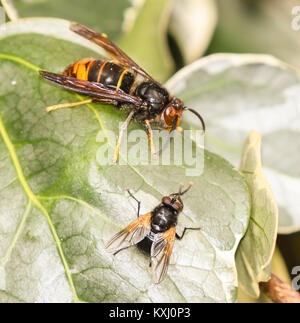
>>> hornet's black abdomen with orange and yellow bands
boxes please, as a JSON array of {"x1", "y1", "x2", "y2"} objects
[{"x1": 63, "y1": 58, "x2": 134, "y2": 93}]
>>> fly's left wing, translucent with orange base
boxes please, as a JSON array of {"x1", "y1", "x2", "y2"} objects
[{"x1": 106, "y1": 213, "x2": 152, "y2": 254}]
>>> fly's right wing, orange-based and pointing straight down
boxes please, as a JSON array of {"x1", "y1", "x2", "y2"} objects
[{"x1": 151, "y1": 227, "x2": 176, "y2": 284}]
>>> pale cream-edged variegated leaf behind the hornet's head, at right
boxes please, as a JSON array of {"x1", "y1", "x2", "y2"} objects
[{"x1": 167, "y1": 54, "x2": 300, "y2": 233}]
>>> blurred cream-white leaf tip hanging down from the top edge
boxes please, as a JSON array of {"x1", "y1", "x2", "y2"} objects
[{"x1": 169, "y1": 0, "x2": 217, "y2": 64}]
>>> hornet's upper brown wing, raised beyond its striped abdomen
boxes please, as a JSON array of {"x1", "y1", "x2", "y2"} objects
[{"x1": 70, "y1": 24, "x2": 157, "y2": 83}]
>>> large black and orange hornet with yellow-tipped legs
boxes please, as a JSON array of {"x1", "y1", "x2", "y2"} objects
[{"x1": 40, "y1": 24, "x2": 205, "y2": 161}]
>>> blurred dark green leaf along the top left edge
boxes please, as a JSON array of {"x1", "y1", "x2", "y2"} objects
[{"x1": 2, "y1": 0, "x2": 132, "y2": 39}]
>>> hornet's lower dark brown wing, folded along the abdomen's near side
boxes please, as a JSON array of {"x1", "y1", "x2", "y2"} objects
[{"x1": 40, "y1": 71, "x2": 142, "y2": 106}]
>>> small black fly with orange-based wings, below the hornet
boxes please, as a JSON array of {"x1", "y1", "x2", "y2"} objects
[{"x1": 106, "y1": 182, "x2": 201, "y2": 284}]
